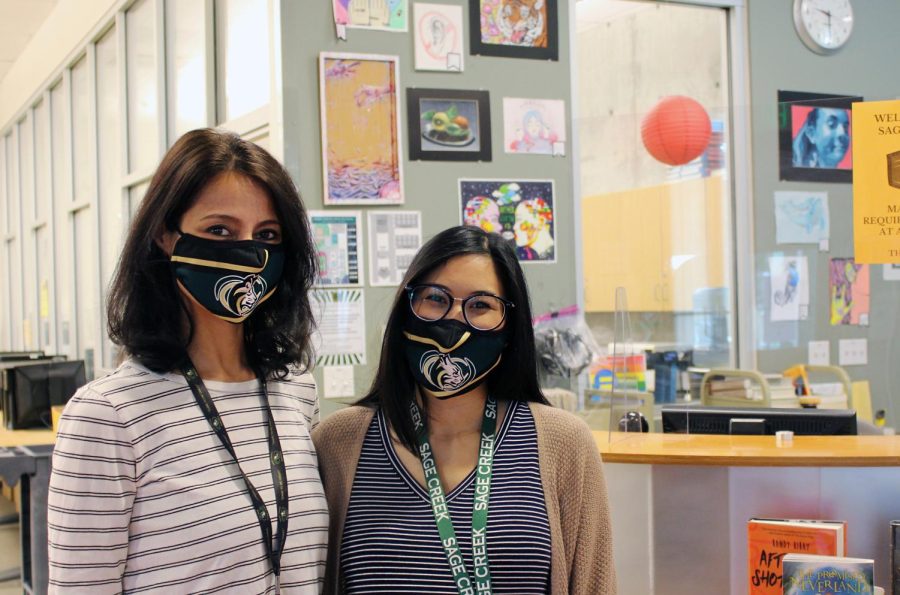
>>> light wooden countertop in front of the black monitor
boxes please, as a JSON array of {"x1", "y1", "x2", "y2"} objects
[{"x1": 594, "y1": 431, "x2": 900, "y2": 467}]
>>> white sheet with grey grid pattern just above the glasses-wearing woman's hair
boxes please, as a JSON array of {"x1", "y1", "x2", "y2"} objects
[{"x1": 369, "y1": 211, "x2": 422, "y2": 287}]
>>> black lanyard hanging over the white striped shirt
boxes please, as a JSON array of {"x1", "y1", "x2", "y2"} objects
[{"x1": 181, "y1": 360, "x2": 288, "y2": 593}]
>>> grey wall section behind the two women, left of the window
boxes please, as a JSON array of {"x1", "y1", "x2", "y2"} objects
[{"x1": 281, "y1": 0, "x2": 576, "y2": 414}]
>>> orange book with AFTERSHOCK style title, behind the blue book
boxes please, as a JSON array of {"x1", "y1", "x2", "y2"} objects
[{"x1": 747, "y1": 518, "x2": 847, "y2": 595}]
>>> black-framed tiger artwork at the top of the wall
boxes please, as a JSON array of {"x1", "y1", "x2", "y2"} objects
[{"x1": 469, "y1": 0, "x2": 559, "y2": 60}]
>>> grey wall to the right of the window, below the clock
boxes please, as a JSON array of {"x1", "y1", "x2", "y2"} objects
[{"x1": 738, "y1": 0, "x2": 900, "y2": 427}]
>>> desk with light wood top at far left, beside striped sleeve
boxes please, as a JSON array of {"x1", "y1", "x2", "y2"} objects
[{"x1": 0, "y1": 414, "x2": 56, "y2": 594}]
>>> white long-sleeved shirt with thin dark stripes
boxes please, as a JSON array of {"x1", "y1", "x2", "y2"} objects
[{"x1": 48, "y1": 362, "x2": 328, "y2": 595}]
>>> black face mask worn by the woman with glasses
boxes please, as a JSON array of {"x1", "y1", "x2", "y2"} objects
[{"x1": 403, "y1": 315, "x2": 506, "y2": 399}]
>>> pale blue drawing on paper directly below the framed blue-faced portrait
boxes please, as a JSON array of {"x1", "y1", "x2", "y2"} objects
[{"x1": 775, "y1": 192, "x2": 831, "y2": 244}]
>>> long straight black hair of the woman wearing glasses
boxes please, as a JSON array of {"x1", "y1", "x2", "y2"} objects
[{"x1": 359, "y1": 225, "x2": 547, "y2": 452}]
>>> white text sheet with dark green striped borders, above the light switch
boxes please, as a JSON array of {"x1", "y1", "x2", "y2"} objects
[{"x1": 310, "y1": 289, "x2": 366, "y2": 366}]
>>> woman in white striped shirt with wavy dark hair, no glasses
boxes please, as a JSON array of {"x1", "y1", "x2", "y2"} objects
[{"x1": 48, "y1": 129, "x2": 328, "y2": 595}]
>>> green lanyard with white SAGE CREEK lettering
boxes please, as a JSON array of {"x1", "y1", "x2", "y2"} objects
[{"x1": 410, "y1": 396, "x2": 497, "y2": 595}]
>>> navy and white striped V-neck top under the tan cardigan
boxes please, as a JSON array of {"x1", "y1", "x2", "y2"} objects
[{"x1": 341, "y1": 402, "x2": 550, "y2": 595}]
